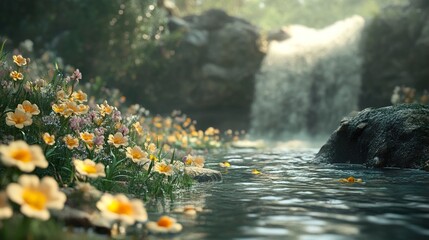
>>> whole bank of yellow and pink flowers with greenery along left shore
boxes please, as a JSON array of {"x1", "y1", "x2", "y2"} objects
[{"x1": 0, "y1": 50, "x2": 242, "y2": 236}]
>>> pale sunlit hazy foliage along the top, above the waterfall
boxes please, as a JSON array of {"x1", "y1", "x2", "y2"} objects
[{"x1": 175, "y1": 0, "x2": 408, "y2": 30}]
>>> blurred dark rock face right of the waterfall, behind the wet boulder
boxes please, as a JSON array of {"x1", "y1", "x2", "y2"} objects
[{"x1": 359, "y1": 0, "x2": 429, "y2": 109}]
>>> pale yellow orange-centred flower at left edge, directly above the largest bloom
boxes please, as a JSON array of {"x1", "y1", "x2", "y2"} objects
[{"x1": 0, "y1": 140, "x2": 48, "y2": 172}]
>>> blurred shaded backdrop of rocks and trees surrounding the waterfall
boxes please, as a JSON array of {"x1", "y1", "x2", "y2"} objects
[{"x1": 0, "y1": 0, "x2": 429, "y2": 137}]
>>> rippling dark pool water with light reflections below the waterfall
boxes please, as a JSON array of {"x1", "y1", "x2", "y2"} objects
[{"x1": 148, "y1": 149, "x2": 429, "y2": 239}]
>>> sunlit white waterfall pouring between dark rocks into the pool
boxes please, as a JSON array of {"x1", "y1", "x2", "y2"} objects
[{"x1": 250, "y1": 16, "x2": 364, "y2": 139}]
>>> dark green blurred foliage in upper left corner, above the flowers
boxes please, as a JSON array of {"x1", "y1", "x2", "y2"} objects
[{"x1": 0, "y1": 0, "x2": 165, "y2": 98}]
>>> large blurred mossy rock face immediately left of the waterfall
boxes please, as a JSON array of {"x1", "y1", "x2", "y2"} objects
[{"x1": 145, "y1": 10, "x2": 265, "y2": 129}]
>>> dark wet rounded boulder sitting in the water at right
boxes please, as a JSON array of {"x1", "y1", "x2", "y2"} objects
[{"x1": 315, "y1": 104, "x2": 429, "y2": 169}]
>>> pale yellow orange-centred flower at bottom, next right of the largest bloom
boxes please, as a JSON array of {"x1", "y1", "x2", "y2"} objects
[{"x1": 97, "y1": 193, "x2": 147, "y2": 225}]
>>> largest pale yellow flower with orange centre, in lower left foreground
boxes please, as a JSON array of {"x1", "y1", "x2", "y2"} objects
[{"x1": 6, "y1": 175, "x2": 66, "y2": 220}]
